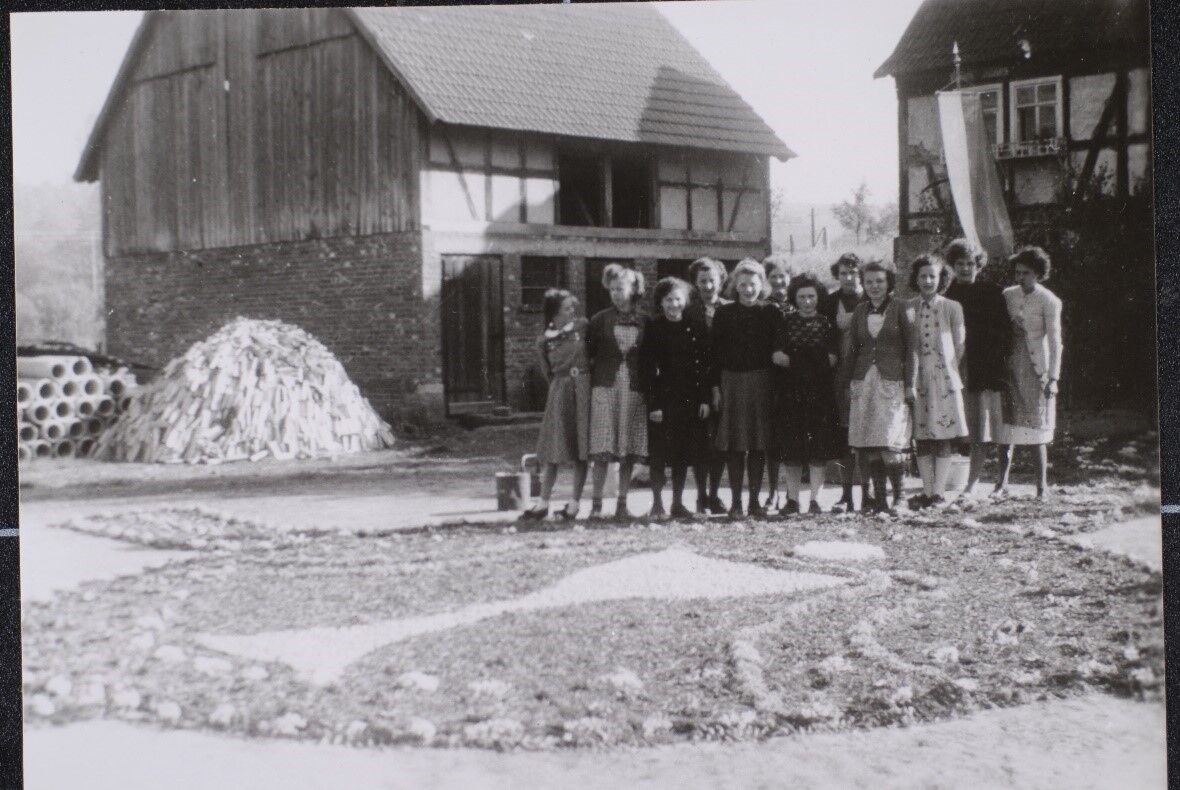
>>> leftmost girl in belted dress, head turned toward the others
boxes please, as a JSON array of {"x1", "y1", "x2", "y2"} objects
[{"x1": 522, "y1": 288, "x2": 590, "y2": 521}]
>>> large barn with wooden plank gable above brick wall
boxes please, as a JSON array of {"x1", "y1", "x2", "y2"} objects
[{"x1": 76, "y1": 5, "x2": 793, "y2": 420}]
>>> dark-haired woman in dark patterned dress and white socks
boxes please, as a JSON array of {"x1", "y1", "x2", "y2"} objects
[{"x1": 772, "y1": 274, "x2": 844, "y2": 514}]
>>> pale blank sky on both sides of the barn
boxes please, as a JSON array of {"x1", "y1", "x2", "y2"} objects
[{"x1": 11, "y1": 0, "x2": 920, "y2": 203}]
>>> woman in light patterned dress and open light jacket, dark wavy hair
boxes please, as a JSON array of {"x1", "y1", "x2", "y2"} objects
[{"x1": 910, "y1": 255, "x2": 968, "y2": 510}]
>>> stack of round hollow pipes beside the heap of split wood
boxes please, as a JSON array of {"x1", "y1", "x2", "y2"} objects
[{"x1": 17, "y1": 355, "x2": 136, "y2": 461}]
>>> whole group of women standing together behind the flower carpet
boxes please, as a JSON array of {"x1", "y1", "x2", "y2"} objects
[{"x1": 524, "y1": 240, "x2": 1062, "y2": 520}]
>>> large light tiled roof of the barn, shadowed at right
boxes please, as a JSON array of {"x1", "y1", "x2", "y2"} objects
[{"x1": 352, "y1": 4, "x2": 794, "y2": 159}]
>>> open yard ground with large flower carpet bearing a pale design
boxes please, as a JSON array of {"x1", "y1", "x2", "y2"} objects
[{"x1": 21, "y1": 410, "x2": 1163, "y2": 786}]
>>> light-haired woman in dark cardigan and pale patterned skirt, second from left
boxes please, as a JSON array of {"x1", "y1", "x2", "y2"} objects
[{"x1": 586, "y1": 263, "x2": 648, "y2": 520}]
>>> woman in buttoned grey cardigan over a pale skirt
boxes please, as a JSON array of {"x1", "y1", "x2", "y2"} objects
[{"x1": 840, "y1": 261, "x2": 918, "y2": 512}]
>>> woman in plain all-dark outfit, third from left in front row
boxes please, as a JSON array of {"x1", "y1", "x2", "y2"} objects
[{"x1": 640, "y1": 278, "x2": 710, "y2": 518}]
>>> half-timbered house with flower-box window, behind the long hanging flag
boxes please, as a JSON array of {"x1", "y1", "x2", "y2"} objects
[{"x1": 876, "y1": 0, "x2": 1152, "y2": 272}]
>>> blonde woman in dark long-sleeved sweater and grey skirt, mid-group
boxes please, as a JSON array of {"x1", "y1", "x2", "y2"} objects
[{"x1": 709, "y1": 259, "x2": 782, "y2": 517}]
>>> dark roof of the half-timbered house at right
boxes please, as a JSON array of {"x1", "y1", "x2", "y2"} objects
[{"x1": 874, "y1": 0, "x2": 1148, "y2": 77}]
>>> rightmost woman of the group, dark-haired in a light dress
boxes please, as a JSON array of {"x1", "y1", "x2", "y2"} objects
[{"x1": 996, "y1": 247, "x2": 1064, "y2": 497}]
